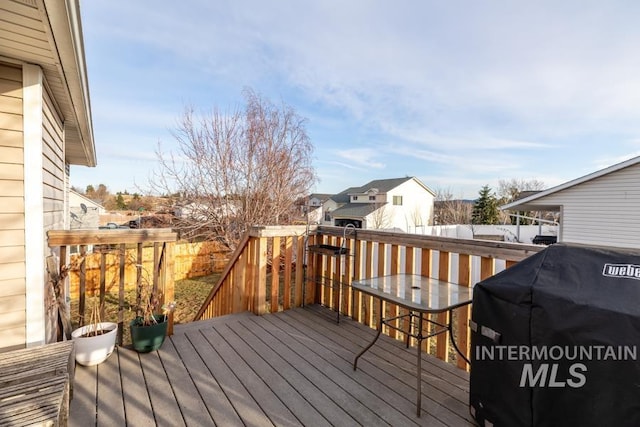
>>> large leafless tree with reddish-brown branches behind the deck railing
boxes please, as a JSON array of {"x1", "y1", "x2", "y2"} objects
[{"x1": 152, "y1": 89, "x2": 317, "y2": 249}]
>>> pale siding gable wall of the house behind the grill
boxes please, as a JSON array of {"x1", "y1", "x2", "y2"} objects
[{"x1": 528, "y1": 164, "x2": 640, "y2": 248}]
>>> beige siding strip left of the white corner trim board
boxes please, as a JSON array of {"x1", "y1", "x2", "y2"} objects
[{"x1": 0, "y1": 63, "x2": 26, "y2": 349}]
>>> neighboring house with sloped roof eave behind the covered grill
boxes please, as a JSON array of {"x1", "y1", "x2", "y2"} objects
[{"x1": 500, "y1": 157, "x2": 640, "y2": 248}]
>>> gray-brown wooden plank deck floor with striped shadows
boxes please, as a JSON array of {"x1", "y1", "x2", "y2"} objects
[{"x1": 69, "y1": 306, "x2": 474, "y2": 427}]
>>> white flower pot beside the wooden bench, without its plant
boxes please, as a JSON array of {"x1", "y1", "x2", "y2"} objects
[{"x1": 71, "y1": 322, "x2": 118, "y2": 366}]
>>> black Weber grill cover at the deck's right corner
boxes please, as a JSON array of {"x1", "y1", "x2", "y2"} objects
[{"x1": 469, "y1": 244, "x2": 640, "y2": 427}]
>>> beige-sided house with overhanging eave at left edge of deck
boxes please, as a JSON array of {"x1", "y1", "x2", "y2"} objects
[{"x1": 0, "y1": 0, "x2": 96, "y2": 351}]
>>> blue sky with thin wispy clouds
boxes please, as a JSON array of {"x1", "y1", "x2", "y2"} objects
[{"x1": 71, "y1": 0, "x2": 640, "y2": 198}]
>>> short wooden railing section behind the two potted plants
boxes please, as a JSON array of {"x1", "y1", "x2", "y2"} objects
[{"x1": 47, "y1": 229, "x2": 177, "y2": 344}]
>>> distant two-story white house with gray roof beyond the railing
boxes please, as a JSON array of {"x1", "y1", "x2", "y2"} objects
[{"x1": 323, "y1": 177, "x2": 435, "y2": 232}]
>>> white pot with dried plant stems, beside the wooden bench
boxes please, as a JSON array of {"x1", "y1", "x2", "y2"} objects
[{"x1": 71, "y1": 300, "x2": 118, "y2": 366}]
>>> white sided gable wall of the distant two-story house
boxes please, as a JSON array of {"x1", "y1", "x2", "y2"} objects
[{"x1": 383, "y1": 179, "x2": 434, "y2": 232}]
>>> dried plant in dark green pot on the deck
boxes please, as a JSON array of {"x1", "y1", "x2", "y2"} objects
[{"x1": 129, "y1": 265, "x2": 175, "y2": 353}]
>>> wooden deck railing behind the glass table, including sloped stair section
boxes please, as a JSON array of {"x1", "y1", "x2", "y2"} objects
[{"x1": 194, "y1": 226, "x2": 543, "y2": 368}]
